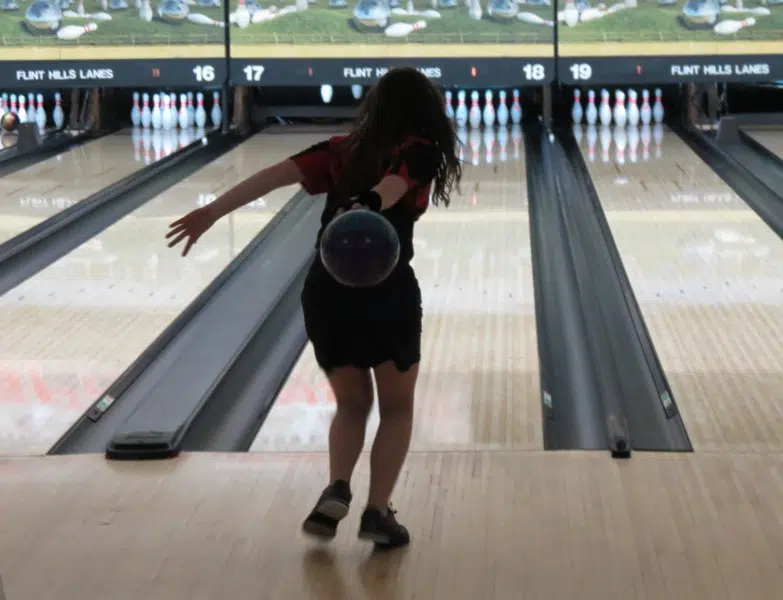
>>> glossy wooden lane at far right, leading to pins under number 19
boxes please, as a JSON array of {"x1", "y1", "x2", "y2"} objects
[{"x1": 583, "y1": 130, "x2": 783, "y2": 452}]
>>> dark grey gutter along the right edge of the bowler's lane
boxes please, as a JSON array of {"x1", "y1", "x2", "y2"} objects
[{"x1": 524, "y1": 123, "x2": 624, "y2": 452}]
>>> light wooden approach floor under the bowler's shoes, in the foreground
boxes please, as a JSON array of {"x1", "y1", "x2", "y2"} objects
[{"x1": 0, "y1": 451, "x2": 783, "y2": 600}]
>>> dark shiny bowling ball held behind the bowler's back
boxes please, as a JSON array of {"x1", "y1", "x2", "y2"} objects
[{"x1": 320, "y1": 209, "x2": 400, "y2": 288}]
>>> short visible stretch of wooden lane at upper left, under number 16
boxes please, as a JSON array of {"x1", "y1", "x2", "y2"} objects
[{"x1": 0, "y1": 130, "x2": 169, "y2": 244}]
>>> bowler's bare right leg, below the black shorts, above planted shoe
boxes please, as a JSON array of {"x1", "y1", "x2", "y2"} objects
[{"x1": 367, "y1": 362, "x2": 419, "y2": 512}]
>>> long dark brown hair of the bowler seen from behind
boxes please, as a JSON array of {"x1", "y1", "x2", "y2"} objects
[{"x1": 340, "y1": 67, "x2": 462, "y2": 206}]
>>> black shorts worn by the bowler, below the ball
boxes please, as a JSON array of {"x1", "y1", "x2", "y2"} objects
[{"x1": 302, "y1": 258, "x2": 422, "y2": 373}]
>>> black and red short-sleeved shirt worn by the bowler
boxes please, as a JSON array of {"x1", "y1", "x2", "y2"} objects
[{"x1": 291, "y1": 136, "x2": 440, "y2": 262}]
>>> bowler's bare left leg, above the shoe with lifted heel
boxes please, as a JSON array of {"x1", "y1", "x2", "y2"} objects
[{"x1": 329, "y1": 367, "x2": 373, "y2": 483}]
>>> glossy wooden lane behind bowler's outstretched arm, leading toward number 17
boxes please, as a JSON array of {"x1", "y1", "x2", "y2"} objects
[{"x1": 0, "y1": 128, "x2": 340, "y2": 455}]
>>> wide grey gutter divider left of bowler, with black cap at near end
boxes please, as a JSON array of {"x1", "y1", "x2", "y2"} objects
[{"x1": 50, "y1": 192, "x2": 320, "y2": 459}]
